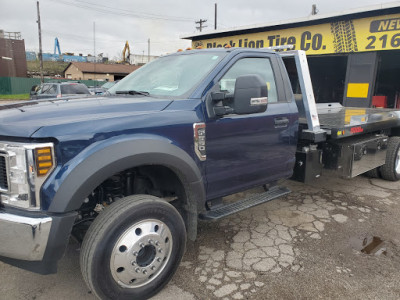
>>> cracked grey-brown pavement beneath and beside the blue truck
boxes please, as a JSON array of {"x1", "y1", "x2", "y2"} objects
[{"x1": 0, "y1": 176, "x2": 400, "y2": 300}]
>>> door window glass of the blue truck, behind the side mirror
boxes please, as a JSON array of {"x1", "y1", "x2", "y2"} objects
[{"x1": 219, "y1": 57, "x2": 278, "y2": 103}]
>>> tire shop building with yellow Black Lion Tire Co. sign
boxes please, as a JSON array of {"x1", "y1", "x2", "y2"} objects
[{"x1": 183, "y1": 2, "x2": 400, "y2": 108}]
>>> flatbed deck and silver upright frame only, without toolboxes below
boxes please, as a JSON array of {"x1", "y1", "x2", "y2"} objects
[{"x1": 279, "y1": 50, "x2": 400, "y2": 143}]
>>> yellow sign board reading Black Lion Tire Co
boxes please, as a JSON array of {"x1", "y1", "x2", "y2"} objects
[{"x1": 192, "y1": 14, "x2": 400, "y2": 55}]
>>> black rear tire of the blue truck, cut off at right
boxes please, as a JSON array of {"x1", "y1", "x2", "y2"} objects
[{"x1": 380, "y1": 136, "x2": 400, "y2": 181}]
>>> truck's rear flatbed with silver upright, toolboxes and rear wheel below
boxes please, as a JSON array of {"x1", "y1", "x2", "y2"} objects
[{"x1": 279, "y1": 50, "x2": 400, "y2": 182}]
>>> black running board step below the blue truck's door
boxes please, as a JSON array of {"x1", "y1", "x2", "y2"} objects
[{"x1": 199, "y1": 187, "x2": 290, "y2": 220}]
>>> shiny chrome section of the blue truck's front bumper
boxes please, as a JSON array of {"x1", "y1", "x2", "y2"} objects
[{"x1": 0, "y1": 212, "x2": 52, "y2": 261}]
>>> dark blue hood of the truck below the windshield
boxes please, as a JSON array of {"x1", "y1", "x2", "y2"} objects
[{"x1": 0, "y1": 95, "x2": 172, "y2": 137}]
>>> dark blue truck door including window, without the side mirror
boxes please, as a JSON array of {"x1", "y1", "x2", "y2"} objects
[{"x1": 206, "y1": 53, "x2": 297, "y2": 199}]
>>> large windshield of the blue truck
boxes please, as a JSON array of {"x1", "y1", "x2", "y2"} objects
[{"x1": 108, "y1": 52, "x2": 226, "y2": 96}]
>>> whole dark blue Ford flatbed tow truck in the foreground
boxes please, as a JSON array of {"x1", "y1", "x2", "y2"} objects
[{"x1": 0, "y1": 48, "x2": 400, "y2": 299}]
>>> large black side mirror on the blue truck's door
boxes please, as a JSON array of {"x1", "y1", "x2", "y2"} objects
[{"x1": 232, "y1": 74, "x2": 268, "y2": 115}]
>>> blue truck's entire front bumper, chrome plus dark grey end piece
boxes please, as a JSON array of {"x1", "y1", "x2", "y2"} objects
[{"x1": 0, "y1": 207, "x2": 77, "y2": 274}]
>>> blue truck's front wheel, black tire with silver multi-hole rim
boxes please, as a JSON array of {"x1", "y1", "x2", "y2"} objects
[{"x1": 80, "y1": 195, "x2": 186, "y2": 299}]
